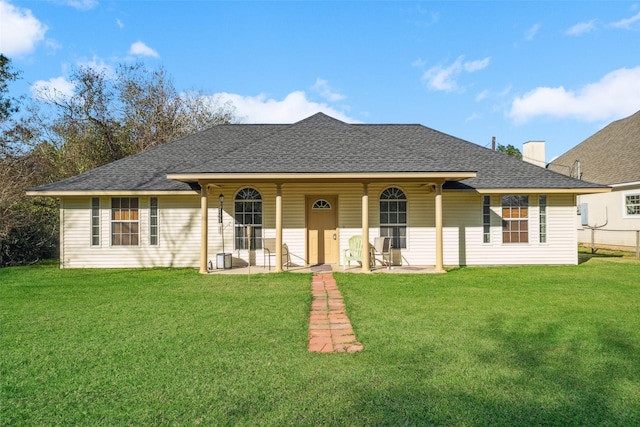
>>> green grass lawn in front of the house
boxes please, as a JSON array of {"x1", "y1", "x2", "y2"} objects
[{"x1": 0, "y1": 257, "x2": 640, "y2": 426}]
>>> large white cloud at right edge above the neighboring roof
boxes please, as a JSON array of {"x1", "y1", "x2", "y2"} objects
[{"x1": 509, "y1": 66, "x2": 640, "y2": 123}]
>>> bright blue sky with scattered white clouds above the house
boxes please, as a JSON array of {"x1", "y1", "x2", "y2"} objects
[{"x1": 0, "y1": 0, "x2": 640, "y2": 161}]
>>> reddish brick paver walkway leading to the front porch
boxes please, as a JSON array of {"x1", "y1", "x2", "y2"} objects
[{"x1": 309, "y1": 273, "x2": 362, "y2": 353}]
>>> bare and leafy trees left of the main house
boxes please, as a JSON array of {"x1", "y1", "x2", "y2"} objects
[{"x1": 0, "y1": 61, "x2": 235, "y2": 266}]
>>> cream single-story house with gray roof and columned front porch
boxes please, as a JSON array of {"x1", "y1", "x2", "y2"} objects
[{"x1": 28, "y1": 113, "x2": 610, "y2": 273}]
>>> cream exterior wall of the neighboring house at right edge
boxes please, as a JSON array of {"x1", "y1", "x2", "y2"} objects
[{"x1": 577, "y1": 185, "x2": 640, "y2": 250}]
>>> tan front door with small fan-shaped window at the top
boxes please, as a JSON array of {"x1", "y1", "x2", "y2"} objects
[{"x1": 306, "y1": 196, "x2": 338, "y2": 265}]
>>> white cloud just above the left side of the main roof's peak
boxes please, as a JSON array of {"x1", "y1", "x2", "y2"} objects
[{"x1": 212, "y1": 91, "x2": 357, "y2": 123}]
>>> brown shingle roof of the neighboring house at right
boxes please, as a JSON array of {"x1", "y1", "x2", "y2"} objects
[{"x1": 549, "y1": 111, "x2": 640, "y2": 184}]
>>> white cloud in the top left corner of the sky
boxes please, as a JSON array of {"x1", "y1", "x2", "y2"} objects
[{"x1": 0, "y1": 0, "x2": 47, "y2": 57}]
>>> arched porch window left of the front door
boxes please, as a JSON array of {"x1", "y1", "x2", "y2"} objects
[{"x1": 235, "y1": 188, "x2": 262, "y2": 249}]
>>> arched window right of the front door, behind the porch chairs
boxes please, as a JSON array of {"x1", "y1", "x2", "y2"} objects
[{"x1": 380, "y1": 187, "x2": 407, "y2": 248}]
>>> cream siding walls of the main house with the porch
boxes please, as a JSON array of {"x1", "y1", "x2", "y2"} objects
[{"x1": 61, "y1": 184, "x2": 577, "y2": 268}]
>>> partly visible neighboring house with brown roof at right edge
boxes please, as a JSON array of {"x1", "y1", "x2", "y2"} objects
[{"x1": 548, "y1": 111, "x2": 640, "y2": 249}]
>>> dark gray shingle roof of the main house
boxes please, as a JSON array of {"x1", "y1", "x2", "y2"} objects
[{"x1": 32, "y1": 113, "x2": 602, "y2": 192}]
